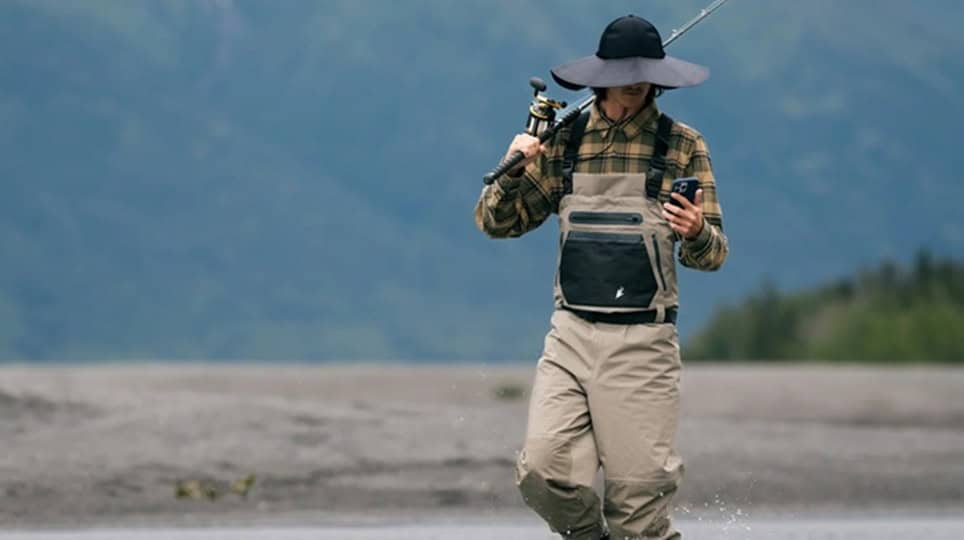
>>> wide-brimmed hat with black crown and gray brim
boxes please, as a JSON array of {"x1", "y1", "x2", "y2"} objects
[{"x1": 552, "y1": 15, "x2": 710, "y2": 90}]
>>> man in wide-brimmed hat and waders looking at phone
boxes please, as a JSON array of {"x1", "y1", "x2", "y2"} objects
[{"x1": 475, "y1": 15, "x2": 727, "y2": 540}]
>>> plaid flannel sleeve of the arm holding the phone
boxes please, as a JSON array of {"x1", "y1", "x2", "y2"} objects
[{"x1": 679, "y1": 136, "x2": 729, "y2": 272}]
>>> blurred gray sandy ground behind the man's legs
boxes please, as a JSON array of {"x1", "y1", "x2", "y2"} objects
[{"x1": 0, "y1": 364, "x2": 964, "y2": 528}]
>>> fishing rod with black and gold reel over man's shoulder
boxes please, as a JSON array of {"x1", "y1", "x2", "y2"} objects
[{"x1": 482, "y1": 0, "x2": 727, "y2": 185}]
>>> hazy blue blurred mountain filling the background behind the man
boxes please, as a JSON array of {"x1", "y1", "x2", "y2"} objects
[{"x1": 0, "y1": 0, "x2": 964, "y2": 360}]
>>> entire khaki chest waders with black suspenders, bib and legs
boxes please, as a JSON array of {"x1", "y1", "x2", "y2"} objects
[{"x1": 516, "y1": 112, "x2": 683, "y2": 540}]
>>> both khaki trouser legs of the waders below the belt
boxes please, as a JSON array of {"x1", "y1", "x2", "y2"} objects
[{"x1": 516, "y1": 310, "x2": 683, "y2": 540}]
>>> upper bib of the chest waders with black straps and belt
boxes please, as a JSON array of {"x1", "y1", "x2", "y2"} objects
[{"x1": 555, "y1": 112, "x2": 679, "y2": 323}]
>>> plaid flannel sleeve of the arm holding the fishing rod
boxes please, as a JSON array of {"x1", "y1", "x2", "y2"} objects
[{"x1": 475, "y1": 140, "x2": 558, "y2": 238}]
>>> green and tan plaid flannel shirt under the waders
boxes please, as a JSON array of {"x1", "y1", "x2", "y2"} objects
[{"x1": 475, "y1": 98, "x2": 728, "y2": 271}]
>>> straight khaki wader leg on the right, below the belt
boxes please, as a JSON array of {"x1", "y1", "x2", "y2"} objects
[{"x1": 589, "y1": 314, "x2": 683, "y2": 540}]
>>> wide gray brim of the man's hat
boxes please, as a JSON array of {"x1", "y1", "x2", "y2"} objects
[{"x1": 551, "y1": 55, "x2": 710, "y2": 90}]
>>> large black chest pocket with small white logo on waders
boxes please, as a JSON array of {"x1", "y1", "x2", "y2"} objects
[{"x1": 559, "y1": 231, "x2": 658, "y2": 309}]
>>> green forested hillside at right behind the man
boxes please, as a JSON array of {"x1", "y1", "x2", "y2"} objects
[{"x1": 684, "y1": 251, "x2": 964, "y2": 362}]
